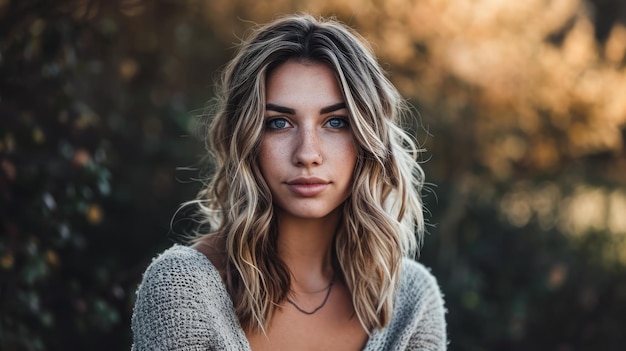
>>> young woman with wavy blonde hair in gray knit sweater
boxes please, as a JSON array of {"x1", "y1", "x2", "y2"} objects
[{"x1": 132, "y1": 15, "x2": 446, "y2": 350}]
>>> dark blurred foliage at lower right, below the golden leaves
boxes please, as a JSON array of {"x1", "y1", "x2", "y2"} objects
[{"x1": 422, "y1": 186, "x2": 626, "y2": 350}]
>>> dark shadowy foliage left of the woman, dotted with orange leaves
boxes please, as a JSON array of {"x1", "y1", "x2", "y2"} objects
[{"x1": 0, "y1": 3, "x2": 219, "y2": 350}]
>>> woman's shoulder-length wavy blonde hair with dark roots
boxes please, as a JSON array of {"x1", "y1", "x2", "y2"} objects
[{"x1": 192, "y1": 15, "x2": 424, "y2": 333}]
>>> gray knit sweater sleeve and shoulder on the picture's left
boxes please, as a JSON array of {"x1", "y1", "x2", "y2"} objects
[{"x1": 131, "y1": 246, "x2": 245, "y2": 351}]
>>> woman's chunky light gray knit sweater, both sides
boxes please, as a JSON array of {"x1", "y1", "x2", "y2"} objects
[{"x1": 132, "y1": 245, "x2": 446, "y2": 351}]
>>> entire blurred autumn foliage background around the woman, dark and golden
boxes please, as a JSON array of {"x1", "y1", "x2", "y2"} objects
[{"x1": 0, "y1": 0, "x2": 626, "y2": 351}]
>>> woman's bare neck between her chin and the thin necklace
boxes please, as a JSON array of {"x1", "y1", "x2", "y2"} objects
[{"x1": 277, "y1": 211, "x2": 340, "y2": 293}]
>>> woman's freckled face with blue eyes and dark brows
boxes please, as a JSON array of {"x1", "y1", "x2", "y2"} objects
[{"x1": 259, "y1": 61, "x2": 357, "y2": 219}]
